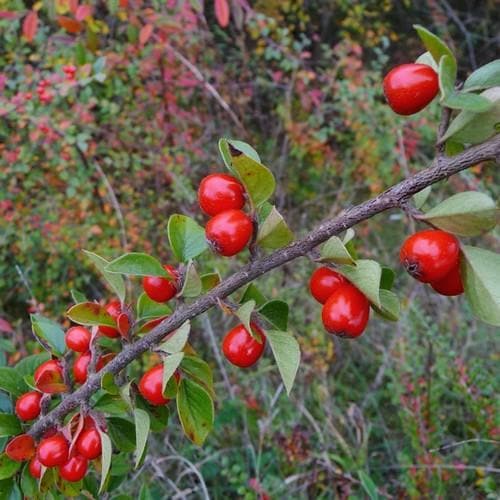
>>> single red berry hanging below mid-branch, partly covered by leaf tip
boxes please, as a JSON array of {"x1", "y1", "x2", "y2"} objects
[{"x1": 222, "y1": 323, "x2": 266, "y2": 368}]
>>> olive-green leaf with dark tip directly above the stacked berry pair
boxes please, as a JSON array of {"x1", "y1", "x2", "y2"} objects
[{"x1": 219, "y1": 139, "x2": 276, "y2": 208}]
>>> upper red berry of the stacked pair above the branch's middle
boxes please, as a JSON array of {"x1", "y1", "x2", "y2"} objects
[{"x1": 198, "y1": 174, "x2": 245, "y2": 216}]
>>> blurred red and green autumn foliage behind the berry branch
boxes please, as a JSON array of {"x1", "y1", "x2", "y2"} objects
[{"x1": 0, "y1": 0, "x2": 500, "y2": 499}]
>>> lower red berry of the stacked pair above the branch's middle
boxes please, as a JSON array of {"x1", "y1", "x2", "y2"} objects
[{"x1": 205, "y1": 210, "x2": 253, "y2": 257}]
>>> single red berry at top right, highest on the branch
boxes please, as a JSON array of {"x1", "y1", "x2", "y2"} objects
[{"x1": 384, "y1": 64, "x2": 439, "y2": 115}]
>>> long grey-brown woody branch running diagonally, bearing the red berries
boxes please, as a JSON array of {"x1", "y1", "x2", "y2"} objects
[{"x1": 29, "y1": 135, "x2": 500, "y2": 437}]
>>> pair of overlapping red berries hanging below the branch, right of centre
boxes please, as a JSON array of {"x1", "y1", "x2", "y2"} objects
[{"x1": 309, "y1": 267, "x2": 370, "y2": 338}]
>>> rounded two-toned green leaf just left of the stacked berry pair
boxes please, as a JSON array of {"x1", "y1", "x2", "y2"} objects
[{"x1": 167, "y1": 214, "x2": 208, "y2": 262}]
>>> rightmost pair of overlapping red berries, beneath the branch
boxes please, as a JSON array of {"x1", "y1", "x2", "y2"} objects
[{"x1": 399, "y1": 229, "x2": 464, "y2": 296}]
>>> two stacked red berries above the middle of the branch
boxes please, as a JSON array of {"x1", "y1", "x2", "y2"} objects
[{"x1": 198, "y1": 174, "x2": 253, "y2": 257}]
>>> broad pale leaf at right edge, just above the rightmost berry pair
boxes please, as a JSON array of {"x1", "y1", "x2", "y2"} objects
[{"x1": 419, "y1": 191, "x2": 499, "y2": 236}]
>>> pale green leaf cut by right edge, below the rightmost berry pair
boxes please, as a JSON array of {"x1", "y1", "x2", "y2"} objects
[{"x1": 460, "y1": 245, "x2": 500, "y2": 326}]
